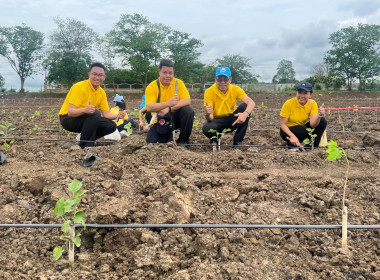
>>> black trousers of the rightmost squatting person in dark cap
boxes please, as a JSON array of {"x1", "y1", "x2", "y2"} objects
[{"x1": 280, "y1": 118, "x2": 327, "y2": 147}]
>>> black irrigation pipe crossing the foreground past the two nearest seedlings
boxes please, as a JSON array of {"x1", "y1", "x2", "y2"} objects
[{"x1": 0, "y1": 224, "x2": 380, "y2": 229}]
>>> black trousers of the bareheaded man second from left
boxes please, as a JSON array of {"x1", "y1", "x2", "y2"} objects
[{"x1": 146, "y1": 106, "x2": 194, "y2": 144}]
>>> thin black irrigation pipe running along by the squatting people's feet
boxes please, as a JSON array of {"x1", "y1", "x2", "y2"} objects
[{"x1": 0, "y1": 136, "x2": 380, "y2": 150}]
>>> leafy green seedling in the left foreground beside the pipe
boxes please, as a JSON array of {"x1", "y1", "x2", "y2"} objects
[{"x1": 53, "y1": 179, "x2": 87, "y2": 265}]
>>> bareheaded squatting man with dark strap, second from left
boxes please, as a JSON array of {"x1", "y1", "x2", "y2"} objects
[{"x1": 145, "y1": 59, "x2": 194, "y2": 148}]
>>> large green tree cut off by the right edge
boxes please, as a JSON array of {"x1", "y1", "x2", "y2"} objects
[{"x1": 325, "y1": 24, "x2": 380, "y2": 89}]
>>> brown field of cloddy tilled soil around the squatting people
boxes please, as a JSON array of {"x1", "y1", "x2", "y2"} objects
[{"x1": 0, "y1": 92, "x2": 380, "y2": 280}]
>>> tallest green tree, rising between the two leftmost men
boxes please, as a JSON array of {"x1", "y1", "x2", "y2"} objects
[{"x1": 107, "y1": 14, "x2": 170, "y2": 88}]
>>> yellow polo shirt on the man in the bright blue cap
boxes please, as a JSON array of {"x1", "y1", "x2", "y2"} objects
[{"x1": 204, "y1": 84, "x2": 247, "y2": 118}]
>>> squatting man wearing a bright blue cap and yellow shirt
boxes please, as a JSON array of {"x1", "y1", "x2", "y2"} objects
[{"x1": 202, "y1": 66, "x2": 255, "y2": 146}]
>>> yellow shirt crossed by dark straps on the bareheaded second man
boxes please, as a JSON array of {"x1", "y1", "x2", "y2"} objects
[{"x1": 145, "y1": 78, "x2": 190, "y2": 123}]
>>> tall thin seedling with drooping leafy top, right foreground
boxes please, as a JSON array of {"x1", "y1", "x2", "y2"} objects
[{"x1": 326, "y1": 140, "x2": 350, "y2": 250}]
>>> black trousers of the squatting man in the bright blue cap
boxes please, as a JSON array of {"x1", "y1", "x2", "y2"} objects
[{"x1": 202, "y1": 103, "x2": 250, "y2": 144}]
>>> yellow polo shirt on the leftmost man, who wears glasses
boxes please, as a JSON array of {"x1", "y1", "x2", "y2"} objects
[{"x1": 59, "y1": 80, "x2": 109, "y2": 115}]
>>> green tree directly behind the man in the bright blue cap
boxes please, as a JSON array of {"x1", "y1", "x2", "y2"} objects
[{"x1": 215, "y1": 54, "x2": 258, "y2": 83}]
